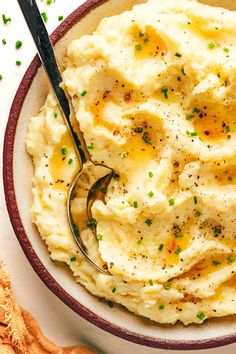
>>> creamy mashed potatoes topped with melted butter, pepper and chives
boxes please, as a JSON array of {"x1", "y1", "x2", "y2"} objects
[{"x1": 27, "y1": 0, "x2": 236, "y2": 325}]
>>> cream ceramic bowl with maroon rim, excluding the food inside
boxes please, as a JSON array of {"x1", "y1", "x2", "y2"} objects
[{"x1": 4, "y1": 0, "x2": 236, "y2": 350}]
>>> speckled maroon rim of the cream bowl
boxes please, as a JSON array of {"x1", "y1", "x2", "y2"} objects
[{"x1": 3, "y1": 0, "x2": 236, "y2": 350}]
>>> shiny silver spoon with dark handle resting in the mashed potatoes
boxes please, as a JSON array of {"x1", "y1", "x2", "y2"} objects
[{"x1": 18, "y1": 0, "x2": 114, "y2": 275}]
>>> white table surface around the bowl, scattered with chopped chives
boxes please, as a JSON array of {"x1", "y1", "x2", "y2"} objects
[{"x1": 0, "y1": 0, "x2": 236, "y2": 354}]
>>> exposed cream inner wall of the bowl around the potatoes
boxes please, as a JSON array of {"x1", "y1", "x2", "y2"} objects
[{"x1": 13, "y1": 0, "x2": 236, "y2": 341}]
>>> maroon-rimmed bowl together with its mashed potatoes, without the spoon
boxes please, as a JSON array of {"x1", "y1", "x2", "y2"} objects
[{"x1": 4, "y1": 0, "x2": 236, "y2": 350}]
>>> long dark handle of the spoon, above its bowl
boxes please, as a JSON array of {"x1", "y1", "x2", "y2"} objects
[{"x1": 18, "y1": 0, "x2": 90, "y2": 163}]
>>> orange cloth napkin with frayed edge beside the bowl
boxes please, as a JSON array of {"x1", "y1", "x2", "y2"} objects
[{"x1": 0, "y1": 263, "x2": 95, "y2": 354}]
